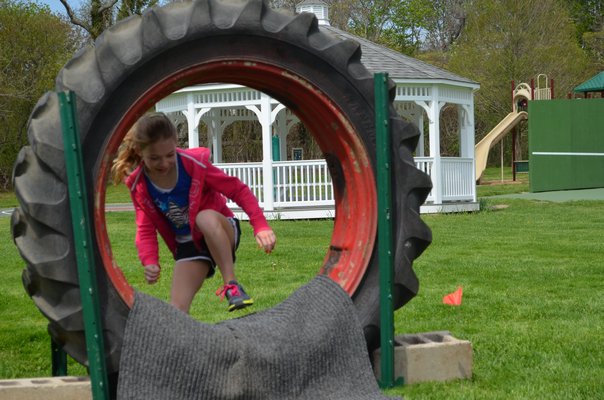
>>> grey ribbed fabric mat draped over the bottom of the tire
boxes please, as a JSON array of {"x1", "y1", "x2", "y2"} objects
[{"x1": 117, "y1": 276, "x2": 402, "y2": 400}]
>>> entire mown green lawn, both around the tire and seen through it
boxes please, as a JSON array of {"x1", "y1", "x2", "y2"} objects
[{"x1": 0, "y1": 179, "x2": 604, "y2": 400}]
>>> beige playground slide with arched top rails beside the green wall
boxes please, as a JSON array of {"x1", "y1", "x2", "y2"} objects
[{"x1": 474, "y1": 74, "x2": 554, "y2": 181}]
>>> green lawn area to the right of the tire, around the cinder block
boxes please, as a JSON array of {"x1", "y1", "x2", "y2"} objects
[{"x1": 396, "y1": 200, "x2": 604, "y2": 399}]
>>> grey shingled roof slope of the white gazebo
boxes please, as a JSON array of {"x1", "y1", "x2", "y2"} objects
[{"x1": 321, "y1": 26, "x2": 480, "y2": 88}]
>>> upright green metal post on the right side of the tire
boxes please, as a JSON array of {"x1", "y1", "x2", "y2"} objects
[{"x1": 374, "y1": 72, "x2": 402, "y2": 388}]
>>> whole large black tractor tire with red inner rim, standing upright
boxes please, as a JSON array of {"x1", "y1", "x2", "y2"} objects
[{"x1": 11, "y1": 0, "x2": 431, "y2": 378}]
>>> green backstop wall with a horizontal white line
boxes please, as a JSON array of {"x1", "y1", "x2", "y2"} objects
[{"x1": 528, "y1": 99, "x2": 604, "y2": 192}]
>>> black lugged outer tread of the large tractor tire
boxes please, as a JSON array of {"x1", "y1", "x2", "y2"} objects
[{"x1": 11, "y1": 0, "x2": 431, "y2": 372}]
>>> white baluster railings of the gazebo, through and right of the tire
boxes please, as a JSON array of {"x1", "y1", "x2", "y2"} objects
[{"x1": 216, "y1": 157, "x2": 475, "y2": 209}]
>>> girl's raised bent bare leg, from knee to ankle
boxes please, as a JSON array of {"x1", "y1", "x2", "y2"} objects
[{"x1": 195, "y1": 210, "x2": 235, "y2": 284}]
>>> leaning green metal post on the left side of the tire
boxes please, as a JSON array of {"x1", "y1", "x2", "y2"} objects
[{"x1": 58, "y1": 92, "x2": 109, "y2": 400}]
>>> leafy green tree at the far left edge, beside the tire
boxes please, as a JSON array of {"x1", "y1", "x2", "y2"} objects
[{"x1": 0, "y1": 0, "x2": 79, "y2": 190}]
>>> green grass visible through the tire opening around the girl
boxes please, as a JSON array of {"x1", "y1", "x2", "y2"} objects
[{"x1": 107, "y1": 212, "x2": 333, "y2": 323}]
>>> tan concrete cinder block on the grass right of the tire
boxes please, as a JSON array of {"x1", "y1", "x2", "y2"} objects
[{"x1": 372, "y1": 331, "x2": 472, "y2": 384}]
